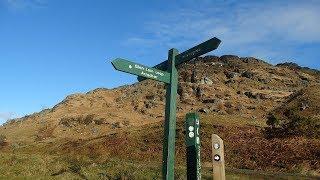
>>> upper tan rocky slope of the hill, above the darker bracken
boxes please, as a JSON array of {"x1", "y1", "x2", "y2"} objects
[{"x1": 0, "y1": 55, "x2": 320, "y2": 142}]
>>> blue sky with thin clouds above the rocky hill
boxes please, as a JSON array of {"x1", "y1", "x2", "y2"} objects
[{"x1": 0, "y1": 0, "x2": 320, "y2": 124}]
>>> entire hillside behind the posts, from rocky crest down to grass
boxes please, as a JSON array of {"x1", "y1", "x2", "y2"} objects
[{"x1": 0, "y1": 55, "x2": 320, "y2": 179}]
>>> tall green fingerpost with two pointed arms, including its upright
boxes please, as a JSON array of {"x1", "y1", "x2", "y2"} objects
[{"x1": 111, "y1": 37, "x2": 221, "y2": 180}]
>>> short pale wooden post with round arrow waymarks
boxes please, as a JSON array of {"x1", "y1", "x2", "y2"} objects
[{"x1": 212, "y1": 134, "x2": 226, "y2": 180}]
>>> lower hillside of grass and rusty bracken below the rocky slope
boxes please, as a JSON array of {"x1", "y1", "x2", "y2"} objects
[{"x1": 0, "y1": 114, "x2": 320, "y2": 179}]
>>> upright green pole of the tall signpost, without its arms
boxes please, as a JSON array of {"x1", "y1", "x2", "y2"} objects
[{"x1": 162, "y1": 49, "x2": 179, "y2": 180}]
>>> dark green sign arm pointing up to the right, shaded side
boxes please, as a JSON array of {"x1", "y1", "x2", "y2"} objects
[{"x1": 138, "y1": 37, "x2": 221, "y2": 81}]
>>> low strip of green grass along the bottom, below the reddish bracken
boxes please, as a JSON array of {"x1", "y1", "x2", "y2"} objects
[{"x1": 0, "y1": 152, "x2": 318, "y2": 180}]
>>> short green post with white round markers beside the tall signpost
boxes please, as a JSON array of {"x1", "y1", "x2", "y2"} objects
[{"x1": 185, "y1": 113, "x2": 201, "y2": 180}]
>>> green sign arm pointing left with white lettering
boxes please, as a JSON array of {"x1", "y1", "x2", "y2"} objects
[{"x1": 111, "y1": 58, "x2": 170, "y2": 84}]
